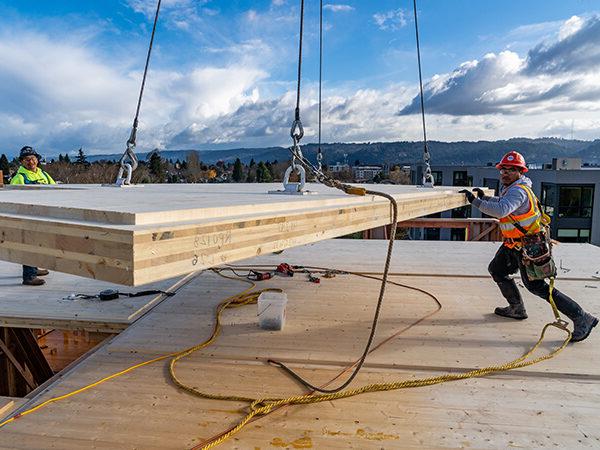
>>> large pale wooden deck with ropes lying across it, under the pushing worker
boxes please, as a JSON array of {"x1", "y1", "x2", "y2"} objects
[{"x1": 0, "y1": 240, "x2": 600, "y2": 449}]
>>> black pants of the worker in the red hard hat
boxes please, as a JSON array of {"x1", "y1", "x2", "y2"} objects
[{"x1": 488, "y1": 245, "x2": 584, "y2": 320}]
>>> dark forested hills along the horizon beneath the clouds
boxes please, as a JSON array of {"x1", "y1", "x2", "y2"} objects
[{"x1": 81, "y1": 138, "x2": 600, "y2": 165}]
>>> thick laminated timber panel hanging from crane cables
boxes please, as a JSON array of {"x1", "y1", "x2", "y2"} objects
[{"x1": 0, "y1": 184, "x2": 482, "y2": 286}]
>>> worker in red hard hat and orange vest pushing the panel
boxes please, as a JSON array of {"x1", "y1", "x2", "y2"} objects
[{"x1": 461, "y1": 151, "x2": 598, "y2": 342}]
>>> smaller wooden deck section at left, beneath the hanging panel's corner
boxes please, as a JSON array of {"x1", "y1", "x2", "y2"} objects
[{"x1": 0, "y1": 261, "x2": 190, "y2": 333}]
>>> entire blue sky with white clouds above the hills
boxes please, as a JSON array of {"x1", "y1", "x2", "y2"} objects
[{"x1": 0, "y1": 0, "x2": 600, "y2": 154}]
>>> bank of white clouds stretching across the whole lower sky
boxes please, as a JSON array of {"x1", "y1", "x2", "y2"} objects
[{"x1": 0, "y1": 11, "x2": 600, "y2": 154}]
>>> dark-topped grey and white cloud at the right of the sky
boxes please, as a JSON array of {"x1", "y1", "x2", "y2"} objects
[{"x1": 400, "y1": 16, "x2": 600, "y2": 116}]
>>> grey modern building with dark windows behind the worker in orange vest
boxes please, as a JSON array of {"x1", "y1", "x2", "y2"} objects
[{"x1": 411, "y1": 158, "x2": 600, "y2": 246}]
